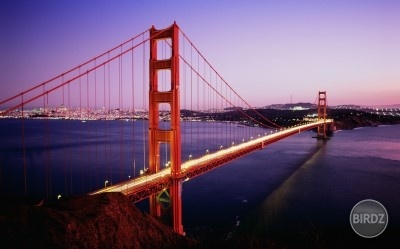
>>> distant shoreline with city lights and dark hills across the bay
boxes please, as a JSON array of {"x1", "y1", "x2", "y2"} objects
[{"x1": 0, "y1": 109, "x2": 400, "y2": 130}]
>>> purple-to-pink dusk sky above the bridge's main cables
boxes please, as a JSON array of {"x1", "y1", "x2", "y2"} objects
[{"x1": 0, "y1": 0, "x2": 400, "y2": 106}]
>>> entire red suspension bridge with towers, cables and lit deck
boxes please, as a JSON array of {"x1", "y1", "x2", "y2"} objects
[{"x1": 0, "y1": 23, "x2": 333, "y2": 234}]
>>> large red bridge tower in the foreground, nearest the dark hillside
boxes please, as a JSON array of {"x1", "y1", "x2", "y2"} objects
[{"x1": 149, "y1": 23, "x2": 183, "y2": 234}]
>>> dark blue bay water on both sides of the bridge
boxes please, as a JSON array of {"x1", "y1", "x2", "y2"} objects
[{"x1": 0, "y1": 119, "x2": 400, "y2": 248}]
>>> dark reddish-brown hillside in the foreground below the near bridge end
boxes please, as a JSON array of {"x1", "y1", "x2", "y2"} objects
[{"x1": 0, "y1": 193, "x2": 193, "y2": 249}]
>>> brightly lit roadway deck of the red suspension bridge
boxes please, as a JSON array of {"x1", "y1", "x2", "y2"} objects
[{"x1": 90, "y1": 119, "x2": 333, "y2": 202}]
